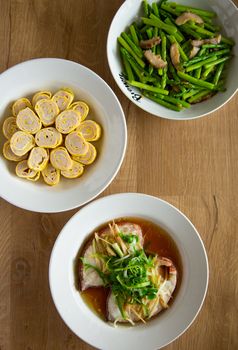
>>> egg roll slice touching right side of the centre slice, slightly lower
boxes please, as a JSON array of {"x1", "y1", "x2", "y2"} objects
[{"x1": 65, "y1": 131, "x2": 89, "y2": 156}]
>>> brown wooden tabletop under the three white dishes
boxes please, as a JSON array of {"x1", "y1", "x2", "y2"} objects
[{"x1": 0, "y1": 0, "x2": 238, "y2": 350}]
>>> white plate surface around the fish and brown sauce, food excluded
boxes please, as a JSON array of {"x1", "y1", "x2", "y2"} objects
[{"x1": 49, "y1": 193, "x2": 208, "y2": 350}]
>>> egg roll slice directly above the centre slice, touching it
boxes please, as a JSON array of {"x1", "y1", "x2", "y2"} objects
[{"x1": 35, "y1": 99, "x2": 59, "y2": 126}]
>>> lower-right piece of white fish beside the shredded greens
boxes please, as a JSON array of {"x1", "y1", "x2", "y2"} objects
[{"x1": 107, "y1": 258, "x2": 177, "y2": 323}]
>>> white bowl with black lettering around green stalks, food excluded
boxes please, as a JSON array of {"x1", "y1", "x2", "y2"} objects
[{"x1": 107, "y1": 0, "x2": 238, "y2": 120}]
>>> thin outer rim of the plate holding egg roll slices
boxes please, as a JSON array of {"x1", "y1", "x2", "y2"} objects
[{"x1": 0, "y1": 57, "x2": 127, "y2": 213}]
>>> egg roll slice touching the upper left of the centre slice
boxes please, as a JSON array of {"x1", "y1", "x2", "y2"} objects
[{"x1": 16, "y1": 107, "x2": 42, "y2": 134}]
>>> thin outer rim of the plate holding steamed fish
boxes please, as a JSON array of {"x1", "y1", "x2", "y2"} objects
[{"x1": 48, "y1": 192, "x2": 209, "y2": 350}]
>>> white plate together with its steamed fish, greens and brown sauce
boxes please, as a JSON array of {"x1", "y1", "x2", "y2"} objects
[{"x1": 49, "y1": 193, "x2": 208, "y2": 350}]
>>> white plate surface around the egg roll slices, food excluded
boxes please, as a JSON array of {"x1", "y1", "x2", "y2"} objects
[{"x1": 0, "y1": 58, "x2": 127, "y2": 212}]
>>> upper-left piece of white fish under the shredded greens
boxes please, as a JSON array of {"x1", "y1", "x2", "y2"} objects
[{"x1": 80, "y1": 222, "x2": 144, "y2": 290}]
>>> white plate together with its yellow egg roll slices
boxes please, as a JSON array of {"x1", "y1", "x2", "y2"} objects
[{"x1": 0, "y1": 58, "x2": 127, "y2": 213}]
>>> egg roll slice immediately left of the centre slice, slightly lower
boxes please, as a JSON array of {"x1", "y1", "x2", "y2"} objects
[{"x1": 10, "y1": 131, "x2": 35, "y2": 157}]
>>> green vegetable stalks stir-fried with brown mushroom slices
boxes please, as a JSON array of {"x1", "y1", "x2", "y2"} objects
[{"x1": 118, "y1": 0, "x2": 234, "y2": 111}]
